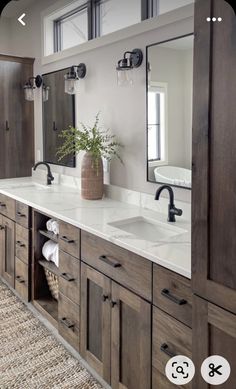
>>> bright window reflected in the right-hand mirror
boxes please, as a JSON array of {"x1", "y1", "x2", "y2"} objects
[{"x1": 148, "y1": 82, "x2": 168, "y2": 163}]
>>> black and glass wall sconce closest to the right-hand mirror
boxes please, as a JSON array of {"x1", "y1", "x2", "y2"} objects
[{"x1": 116, "y1": 49, "x2": 143, "y2": 86}]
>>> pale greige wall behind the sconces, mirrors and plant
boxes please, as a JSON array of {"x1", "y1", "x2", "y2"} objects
[{"x1": 0, "y1": 0, "x2": 193, "y2": 199}]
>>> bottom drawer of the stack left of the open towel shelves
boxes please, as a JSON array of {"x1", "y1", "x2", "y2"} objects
[{"x1": 15, "y1": 258, "x2": 29, "y2": 301}]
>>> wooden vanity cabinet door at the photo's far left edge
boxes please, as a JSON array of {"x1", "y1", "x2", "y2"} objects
[{"x1": 2, "y1": 216, "x2": 15, "y2": 287}]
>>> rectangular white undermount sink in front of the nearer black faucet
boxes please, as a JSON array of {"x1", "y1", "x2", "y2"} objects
[{"x1": 108, "y1": 216, "x2": 187, "y2": 242}]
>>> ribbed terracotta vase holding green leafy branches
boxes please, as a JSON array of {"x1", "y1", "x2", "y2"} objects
[{"x1": 81, "y1": 152, "x2": 103, "y2": 200}]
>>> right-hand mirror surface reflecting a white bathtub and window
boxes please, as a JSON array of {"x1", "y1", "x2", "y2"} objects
[{"x1": 147, "y1": 35, "x2": 193, "y2": 189}]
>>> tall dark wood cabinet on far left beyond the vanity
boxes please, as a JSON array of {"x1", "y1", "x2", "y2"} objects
[{"x1": 0, "y1": 55, "x2": 34, "y2": 178}]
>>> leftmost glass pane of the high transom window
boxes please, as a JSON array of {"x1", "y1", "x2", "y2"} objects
[{"x1": 54, "y1": 4, "x2": 88, "y2": 52}]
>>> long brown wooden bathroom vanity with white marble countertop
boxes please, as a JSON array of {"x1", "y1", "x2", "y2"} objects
[{"x1": 0, "y1": 179, "x2": 192, "y2": 389}]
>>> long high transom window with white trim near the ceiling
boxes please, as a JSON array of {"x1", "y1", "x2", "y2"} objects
[{"x1": 52, "y1": 0, "x2": 159, "y2": 55}]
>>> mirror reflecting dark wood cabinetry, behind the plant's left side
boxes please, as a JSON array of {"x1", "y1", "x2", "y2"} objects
[{"x1": 42, "y1": 69, "x2": 76, "y2": 167}]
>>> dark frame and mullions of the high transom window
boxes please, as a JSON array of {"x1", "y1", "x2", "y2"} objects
[{"x1": 53, "y1": 0, "x2": 159, "y2": 54}]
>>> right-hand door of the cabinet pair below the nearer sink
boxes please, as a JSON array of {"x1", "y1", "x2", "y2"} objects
[{"x1": 111, "y1": 282, "x2": 151, "y2": 389}]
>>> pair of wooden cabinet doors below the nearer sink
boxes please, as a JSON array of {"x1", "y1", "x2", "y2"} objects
[{"x1": 81, "y1": 264, "x2": 151, "y2": 389}]
